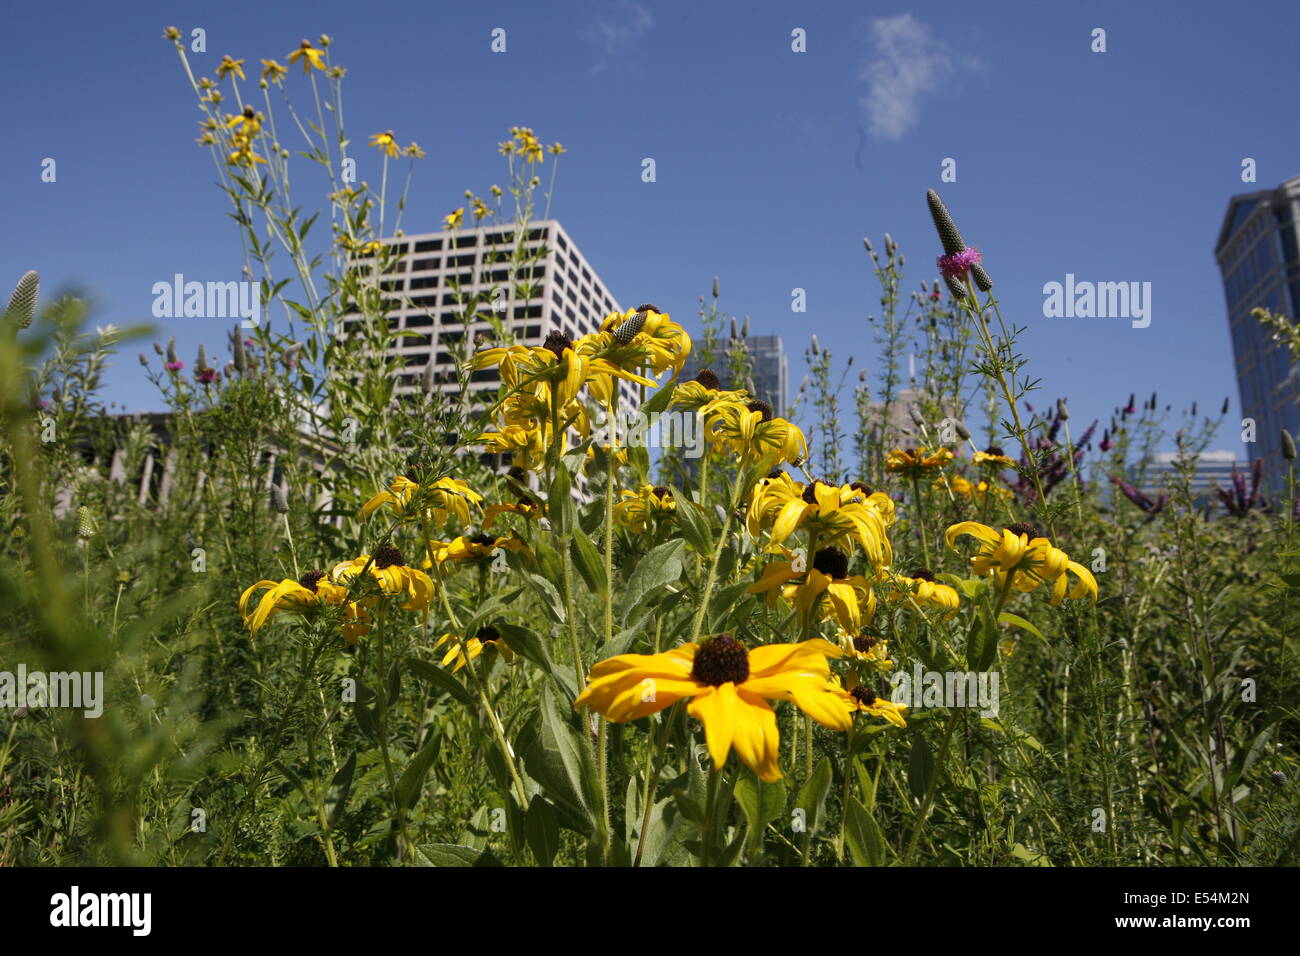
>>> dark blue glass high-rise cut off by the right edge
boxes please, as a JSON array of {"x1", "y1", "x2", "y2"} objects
[{"x1": 1214, "y1": 177, "x2": 1300, "y2": 481}]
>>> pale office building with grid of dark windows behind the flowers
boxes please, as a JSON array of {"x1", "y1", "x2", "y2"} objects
[{"x1": 343, "y1": 220, "x2": 638, "y2": 468}]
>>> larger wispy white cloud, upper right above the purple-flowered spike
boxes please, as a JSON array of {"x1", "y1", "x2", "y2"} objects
[{"x1": 861, "y1": 13, "x2": 980, "y2": 139}]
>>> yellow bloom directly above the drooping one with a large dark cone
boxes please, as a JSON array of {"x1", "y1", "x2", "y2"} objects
[{"x1": 746, "y1": 473, "x2": 893, "y2": 567}]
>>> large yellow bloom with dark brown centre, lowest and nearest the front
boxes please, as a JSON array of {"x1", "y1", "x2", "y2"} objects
[{"x1": 573, "y1": 635, "x2": 852, "y2": 783}]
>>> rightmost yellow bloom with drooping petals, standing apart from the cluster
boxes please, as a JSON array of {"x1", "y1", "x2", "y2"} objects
[{"x1": 944, "y1": 522, "x2": 1097, "y2": 605}]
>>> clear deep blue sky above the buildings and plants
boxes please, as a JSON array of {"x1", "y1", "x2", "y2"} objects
[{"x1": 0, "y1": 0, "x2": 1300, "y2": 445}]
